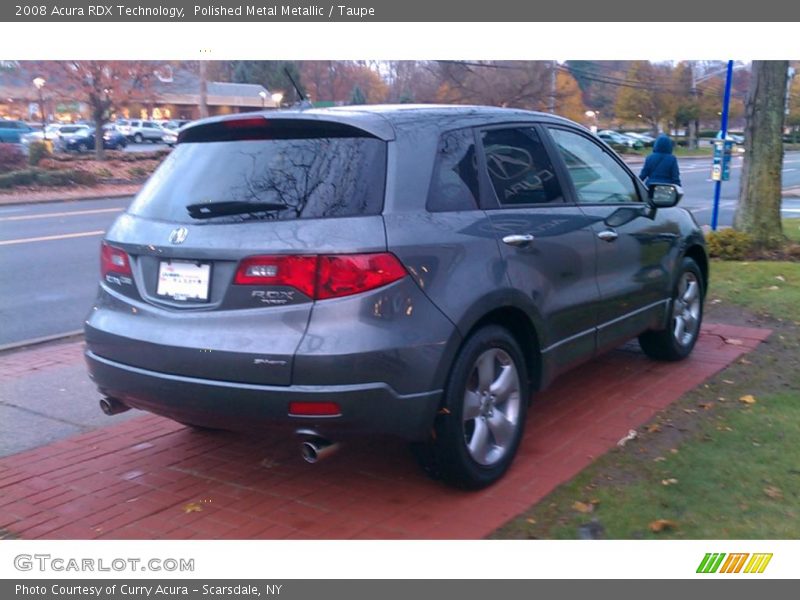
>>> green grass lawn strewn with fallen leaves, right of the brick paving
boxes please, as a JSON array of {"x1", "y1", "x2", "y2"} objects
[{"x1": 494, "y1": 238, "x2": 800, "y2": 539}]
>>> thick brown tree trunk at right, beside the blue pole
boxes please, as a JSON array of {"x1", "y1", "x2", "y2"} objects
[{"x1": 733, "y1": 60, "x2": 789, "y2": 248}]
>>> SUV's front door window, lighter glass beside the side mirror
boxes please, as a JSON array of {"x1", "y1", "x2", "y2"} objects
[{"x1": 550, "y1": 128, "x2": 640, "y2": 204}]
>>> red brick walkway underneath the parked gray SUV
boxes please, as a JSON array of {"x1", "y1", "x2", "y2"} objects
[{"x1": 0, "y1": 325, "x2": 770, "y2": 539}]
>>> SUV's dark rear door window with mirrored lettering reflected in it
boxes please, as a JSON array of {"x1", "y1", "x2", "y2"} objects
[{"x1": 482, "y1": 127, "x2": 564, "y2": 206}]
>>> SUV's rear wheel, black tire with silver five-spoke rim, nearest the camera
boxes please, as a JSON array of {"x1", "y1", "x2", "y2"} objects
[{"x1": 417, "y1": 325, "x2": 530, "y2": 489}]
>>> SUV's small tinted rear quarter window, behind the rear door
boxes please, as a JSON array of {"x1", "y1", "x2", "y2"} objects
[{"x1": 428, "y1": 129, "x2": 478, "y2": 212}]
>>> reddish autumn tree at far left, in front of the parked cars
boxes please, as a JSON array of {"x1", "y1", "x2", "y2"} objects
[{"x1": 38, "y1": 60, "x2": 160, "y2": 160}]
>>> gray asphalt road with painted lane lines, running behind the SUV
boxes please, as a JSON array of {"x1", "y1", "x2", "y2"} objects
[{"x1": 0, "y1": 151, "x2": 800, "y2": 346}]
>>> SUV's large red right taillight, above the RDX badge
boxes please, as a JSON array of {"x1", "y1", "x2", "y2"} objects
[{"x1": 234, "y1": 252, "x2": 406, "y2": 300}]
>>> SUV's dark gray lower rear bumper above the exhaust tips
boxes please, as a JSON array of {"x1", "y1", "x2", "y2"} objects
[{"x1": 86, "y1": 350, "x2": 442, "y2": 440}]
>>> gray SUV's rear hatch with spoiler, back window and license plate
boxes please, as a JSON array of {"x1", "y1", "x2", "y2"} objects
[{"x1": 87, "y1": 116, "x2": 387, "y2": 385}]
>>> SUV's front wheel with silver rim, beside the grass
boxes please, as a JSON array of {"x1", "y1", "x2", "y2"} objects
[{"x1": 639, "y1": 258, "x2": 705, "y2": 361}]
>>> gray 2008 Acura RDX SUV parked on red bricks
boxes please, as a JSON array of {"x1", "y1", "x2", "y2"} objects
[{"x1": 86, "y1": 106, "x2": 708, "y2": 487}]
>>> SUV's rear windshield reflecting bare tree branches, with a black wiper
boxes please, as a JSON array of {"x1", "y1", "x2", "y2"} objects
[{"x1": 130, "y1": 137, "x2": 386, "y2": 223}]
